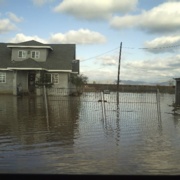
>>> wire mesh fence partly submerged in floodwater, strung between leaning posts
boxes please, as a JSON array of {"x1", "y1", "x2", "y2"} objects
[{"x1": 44, "y1": 89, "x2": 161, "y2": 122}]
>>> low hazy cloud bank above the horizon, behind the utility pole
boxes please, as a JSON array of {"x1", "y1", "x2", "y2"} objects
[{"x1": 81, "y1": 52, "x2": 180, "y2": 83}]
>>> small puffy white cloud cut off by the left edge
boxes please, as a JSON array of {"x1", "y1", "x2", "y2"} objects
[{"x1": 0, "y1": 19, "x2": 16, "y2": 34}]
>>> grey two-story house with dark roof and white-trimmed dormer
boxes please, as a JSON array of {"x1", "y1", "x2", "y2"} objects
[{"x1": 0, "y1": 40, "x2": 79, "y2": 95}]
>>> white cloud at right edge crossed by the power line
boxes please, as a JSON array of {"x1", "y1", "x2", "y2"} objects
[{"x1": 144, "y1": 35, "x2": 180, "y2": 53}]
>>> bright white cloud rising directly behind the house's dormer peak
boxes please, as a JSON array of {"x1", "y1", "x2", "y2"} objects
[{"x1": 9, "y1": 33, "x2": 47, "y2": 43}]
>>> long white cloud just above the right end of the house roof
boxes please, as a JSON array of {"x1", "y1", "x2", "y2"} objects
[{"x1": 48, "y1": 29, "x2": 106, "y2": 44}]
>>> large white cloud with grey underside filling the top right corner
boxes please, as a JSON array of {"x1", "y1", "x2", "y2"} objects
[{"x1": 110, "y1": 1, "x2": 180, "y2": 33}]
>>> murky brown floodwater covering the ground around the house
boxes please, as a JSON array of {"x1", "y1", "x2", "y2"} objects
[{"x1": 0, "y1": 94, "x2": 180, "y2": 175}]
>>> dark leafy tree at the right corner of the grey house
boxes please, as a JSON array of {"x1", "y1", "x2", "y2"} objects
[{"x1": 70, "y1": 74, "x2": 88, "y2": 94}]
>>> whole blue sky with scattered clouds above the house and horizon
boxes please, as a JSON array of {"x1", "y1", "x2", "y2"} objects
[{"x1": 0, "y1": 0, "x2": 180, "y2": 84}]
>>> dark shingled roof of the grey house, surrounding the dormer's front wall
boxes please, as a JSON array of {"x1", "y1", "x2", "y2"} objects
[{"x1": 0, "y1": 40, "x2": 77, "y2": 72}]
